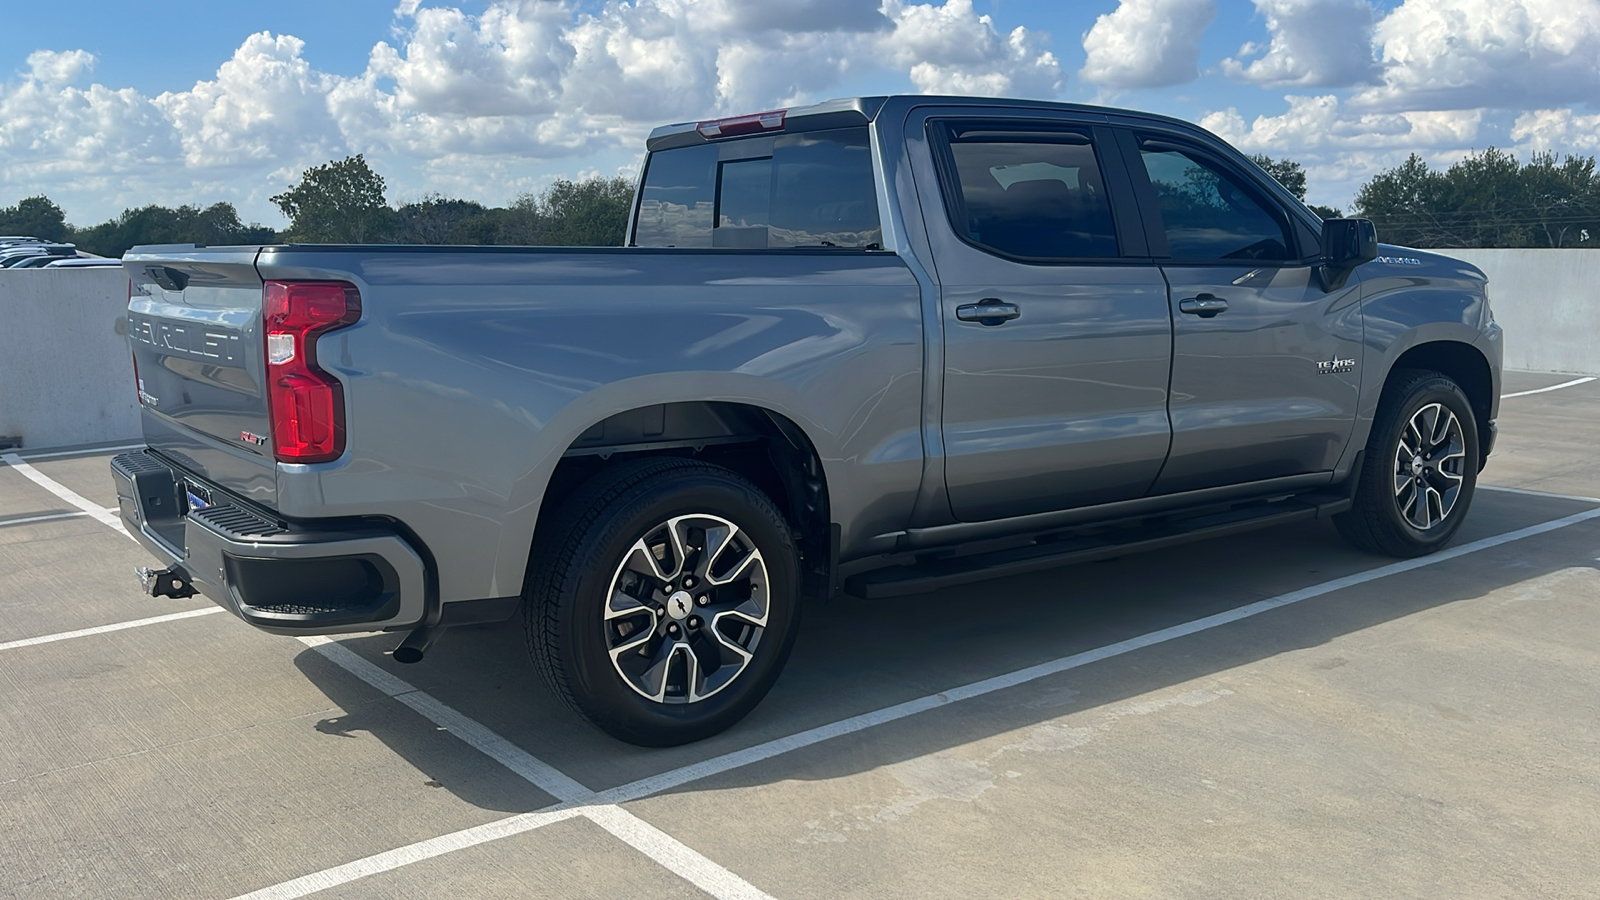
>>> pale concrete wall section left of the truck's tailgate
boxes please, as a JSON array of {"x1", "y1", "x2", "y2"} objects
[{"x1": 0, "y1": 267, "x2": 139, "y2": 450}]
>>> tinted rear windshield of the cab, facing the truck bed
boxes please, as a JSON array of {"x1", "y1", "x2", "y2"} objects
[{"x1": 634, "y1": 128, "x2": 883, "y2": 250}]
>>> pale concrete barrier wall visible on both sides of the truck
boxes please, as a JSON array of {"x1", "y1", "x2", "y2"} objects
[{"x1": 0, "y1": 250, "x2": 1600, "y2": 448}]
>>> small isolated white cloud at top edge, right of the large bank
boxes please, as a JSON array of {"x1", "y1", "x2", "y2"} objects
[{"x1": 1078, "y1": 0, "x2": 1216, "y2": 90}]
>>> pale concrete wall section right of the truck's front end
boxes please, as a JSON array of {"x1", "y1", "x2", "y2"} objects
[{"x1": 1434, "y1": 250, "x2": 1600, "y2": 375}]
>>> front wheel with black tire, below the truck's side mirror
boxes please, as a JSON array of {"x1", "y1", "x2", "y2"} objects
[{"x1": 1333, "y1": 370, "x2": 1478, "y2": 559}]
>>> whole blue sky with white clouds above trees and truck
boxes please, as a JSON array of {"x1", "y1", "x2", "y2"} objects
[{"x1": 0, "y1": 0, "x2": 1600, "y2": 226}]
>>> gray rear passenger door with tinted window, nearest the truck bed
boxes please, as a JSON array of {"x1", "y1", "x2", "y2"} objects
[{"x1": 909, "y1": 114, "x2": 1171, "y2": 520}]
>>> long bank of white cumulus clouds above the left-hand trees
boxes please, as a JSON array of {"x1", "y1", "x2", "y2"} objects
[{"x1": 0, "y1": 0, "x2": 1061, "y2": 218}]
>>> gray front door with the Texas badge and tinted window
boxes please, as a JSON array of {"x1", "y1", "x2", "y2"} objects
[{"x1": 1123, "y1": 133, "x2": 1362, "y2": 493}]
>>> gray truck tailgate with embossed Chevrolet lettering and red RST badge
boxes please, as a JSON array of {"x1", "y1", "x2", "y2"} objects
[{"x1": 123, "y1": 247, "x2": 277, "y2": 506}]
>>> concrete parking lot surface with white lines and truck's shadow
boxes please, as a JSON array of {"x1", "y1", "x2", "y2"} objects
[{"x1": 0, "y1": 373, "x2": 1600, "y2": 900}]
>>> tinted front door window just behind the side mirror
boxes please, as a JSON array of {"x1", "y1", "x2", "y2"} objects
[{"x1": 1139, "y1": 149, "x2": 1291, "y2": 259}]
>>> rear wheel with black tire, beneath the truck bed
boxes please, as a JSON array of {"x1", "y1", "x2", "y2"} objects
[{"x1": 523, "y1": 458, "x2": 800, "y2": 746}]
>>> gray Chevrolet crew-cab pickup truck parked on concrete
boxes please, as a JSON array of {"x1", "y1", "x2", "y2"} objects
[{"x1": 112, "y1": 96, "x2": 1501, "y2": 745}]
